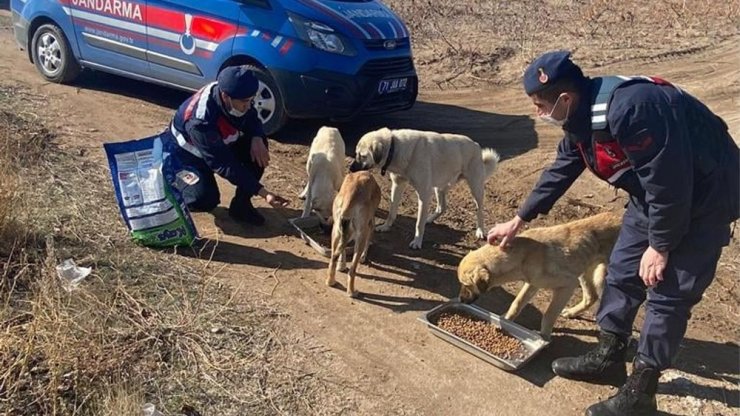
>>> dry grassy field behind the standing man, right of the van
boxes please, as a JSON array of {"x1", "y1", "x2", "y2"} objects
[{"x1": 387, "y1": 0, "x2": 740, "y2": 88}]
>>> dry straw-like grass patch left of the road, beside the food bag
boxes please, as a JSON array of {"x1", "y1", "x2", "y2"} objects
[{"x1": 0, "y1": 87, "x2": 351, "y2": 415}]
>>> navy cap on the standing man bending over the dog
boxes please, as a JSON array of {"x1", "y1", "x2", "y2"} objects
[{"x1": 524, "y1": 51, "x2": 584, "y2": 95}]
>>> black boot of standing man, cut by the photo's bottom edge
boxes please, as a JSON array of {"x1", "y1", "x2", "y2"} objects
[{"x1": 586, "y1": 358, "x2": 660, "y2": 416}]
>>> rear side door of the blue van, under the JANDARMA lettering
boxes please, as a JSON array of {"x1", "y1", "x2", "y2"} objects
[{"x1": 63, "y1": 0, "x2": 149, "y2": 76}]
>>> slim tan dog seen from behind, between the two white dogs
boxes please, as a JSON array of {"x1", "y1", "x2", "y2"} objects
[{"x1": 326, "y1": 172, "x2": 380, "y2": 297}]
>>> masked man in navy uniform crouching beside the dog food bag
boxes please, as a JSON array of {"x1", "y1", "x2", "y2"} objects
[{"x1": 163, "y1": 66, "x2": 288, "y2": 226}]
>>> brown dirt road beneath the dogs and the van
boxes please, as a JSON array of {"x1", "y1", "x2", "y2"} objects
[{"x1": 0, "y1": 8, "x2": 740, "y2": 416}]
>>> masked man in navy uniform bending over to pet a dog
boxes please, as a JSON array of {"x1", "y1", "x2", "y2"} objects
[{"x1": 488, "y1": 51, "x2": 740, "y2": 416}]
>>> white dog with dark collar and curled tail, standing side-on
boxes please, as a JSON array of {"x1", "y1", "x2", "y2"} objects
[{"x1": 350, "y1": 128, "x2": 499, "y2": 249}]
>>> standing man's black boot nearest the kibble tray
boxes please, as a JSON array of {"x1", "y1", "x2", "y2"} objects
[{"x1": 552, "y1": 331, "x2": 627, "y2": 384}]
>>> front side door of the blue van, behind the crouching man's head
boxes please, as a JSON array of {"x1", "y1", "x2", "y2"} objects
[{"x1": 147, "y1": 0, "x2": 240, "y2": 89}]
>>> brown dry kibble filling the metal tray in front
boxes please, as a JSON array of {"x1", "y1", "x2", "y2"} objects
[{"x1": 437, "y1": 312, "x2": 527, "y2": 360}]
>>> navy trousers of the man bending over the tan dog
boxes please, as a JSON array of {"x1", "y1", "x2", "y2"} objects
[{"x1": 597, "y1": 209, "x2": 730, "y2": 370}]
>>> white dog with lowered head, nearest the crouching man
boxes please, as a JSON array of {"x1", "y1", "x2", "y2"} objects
[{"x1": 299, "y1": 127, "x2": 345, "y2": 223}]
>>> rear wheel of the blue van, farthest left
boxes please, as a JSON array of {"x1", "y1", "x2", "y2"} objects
[{"x1": 31, "y1": 24, "x2": 81, "y2": 83}]
